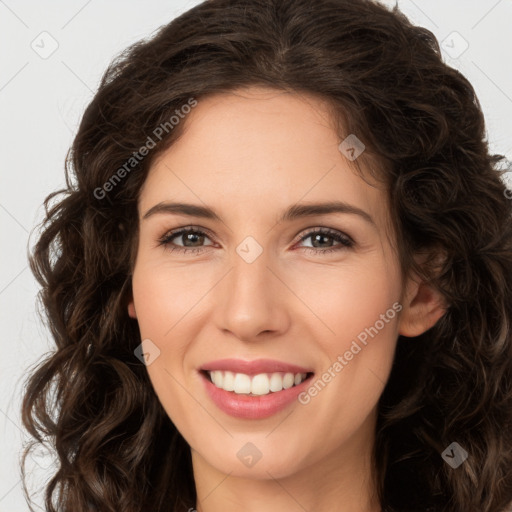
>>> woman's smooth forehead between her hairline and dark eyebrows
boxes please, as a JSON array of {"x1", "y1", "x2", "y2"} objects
[{"x1": 140, "y1": 87, "x2": 387, "y2": 231}]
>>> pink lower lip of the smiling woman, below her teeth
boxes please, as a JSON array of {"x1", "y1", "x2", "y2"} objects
[{"x1": 200, "y1": 372, "x2": 313, "y2": 420}]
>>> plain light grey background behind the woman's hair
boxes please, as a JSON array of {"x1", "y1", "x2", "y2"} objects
[{"x1": 0, "y1": 0, "x2": 512, "y2": 512}]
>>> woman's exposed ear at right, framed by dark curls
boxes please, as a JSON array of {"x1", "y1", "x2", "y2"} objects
[{"x1": 398, "y1": 268, "x2": 446, "y2": 337}]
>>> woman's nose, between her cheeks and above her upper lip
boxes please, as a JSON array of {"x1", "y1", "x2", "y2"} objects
[{"x1": 214, "y1": 245, "x2": 293, "y2": 342}]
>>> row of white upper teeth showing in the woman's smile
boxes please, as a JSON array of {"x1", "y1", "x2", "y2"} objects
[{"x1": 208, "y1": 370, "x2": 307, "y2": 395}]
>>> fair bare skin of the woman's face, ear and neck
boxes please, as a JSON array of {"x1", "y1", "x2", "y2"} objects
[{"x1": 128, "y1": 87, "x2": 444, "y2": 512}]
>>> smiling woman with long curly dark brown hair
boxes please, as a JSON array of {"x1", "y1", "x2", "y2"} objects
[{"x1": 23, "y1": 0, "x2": 512, "y2": 512}]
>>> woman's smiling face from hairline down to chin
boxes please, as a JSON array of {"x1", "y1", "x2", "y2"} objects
[{"x1": 129, "y1": 87, "x2": 438, "y2": 479}]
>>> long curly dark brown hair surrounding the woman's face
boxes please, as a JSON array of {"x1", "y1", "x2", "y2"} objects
[{"x1": 22, "y1": 0, "x2": 512, "y2": 512}]
